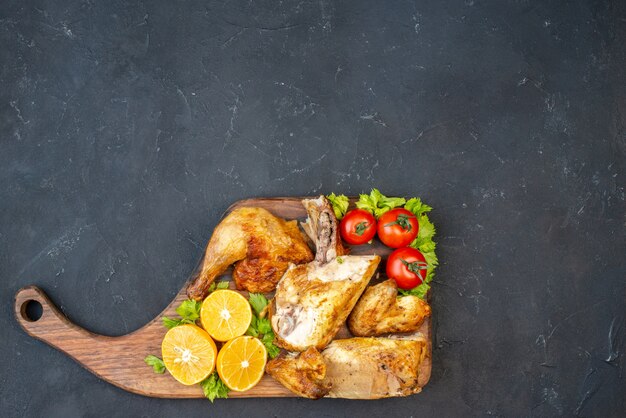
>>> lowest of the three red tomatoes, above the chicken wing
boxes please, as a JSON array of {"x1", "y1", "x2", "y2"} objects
[{"x1": 387, "y1": 247, "x2": 428, "y2": 290}]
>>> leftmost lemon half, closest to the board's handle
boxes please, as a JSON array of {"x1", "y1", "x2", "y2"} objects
[{"x1": 161, "y1": 324, "x2": 217, "y2": 385}]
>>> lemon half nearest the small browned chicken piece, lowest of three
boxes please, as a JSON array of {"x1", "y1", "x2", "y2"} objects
[{"x1": 217, "y1": 336, "x2": 267, "y2": 392}]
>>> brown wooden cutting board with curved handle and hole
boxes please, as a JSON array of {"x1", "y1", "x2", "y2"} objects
[{"x1": 15, "y1": 197, "x2": 432, "y2": 398}]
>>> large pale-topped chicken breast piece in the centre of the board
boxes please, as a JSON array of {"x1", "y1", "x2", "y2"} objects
[{"x1": 270, "y1": 255, "x2": 380, "y2": 351}]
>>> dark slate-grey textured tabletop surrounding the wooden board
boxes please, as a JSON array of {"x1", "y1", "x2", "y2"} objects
[{"x1": 0, "y1": 0, "x2": 626, "y2": 417}]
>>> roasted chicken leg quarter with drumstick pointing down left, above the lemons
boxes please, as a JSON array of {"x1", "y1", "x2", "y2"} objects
[{"x1": 187, "y1": 207, "x2": 313, "y2": 300}]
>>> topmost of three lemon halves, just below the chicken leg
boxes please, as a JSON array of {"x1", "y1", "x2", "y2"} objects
[{"x1": 200, "y1": 290, "x2": 252, "y2": 341}]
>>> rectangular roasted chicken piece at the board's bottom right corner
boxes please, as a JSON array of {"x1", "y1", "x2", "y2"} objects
[{"x1": 322, "y1": 336, "x2": 429, "y2": 399}]
